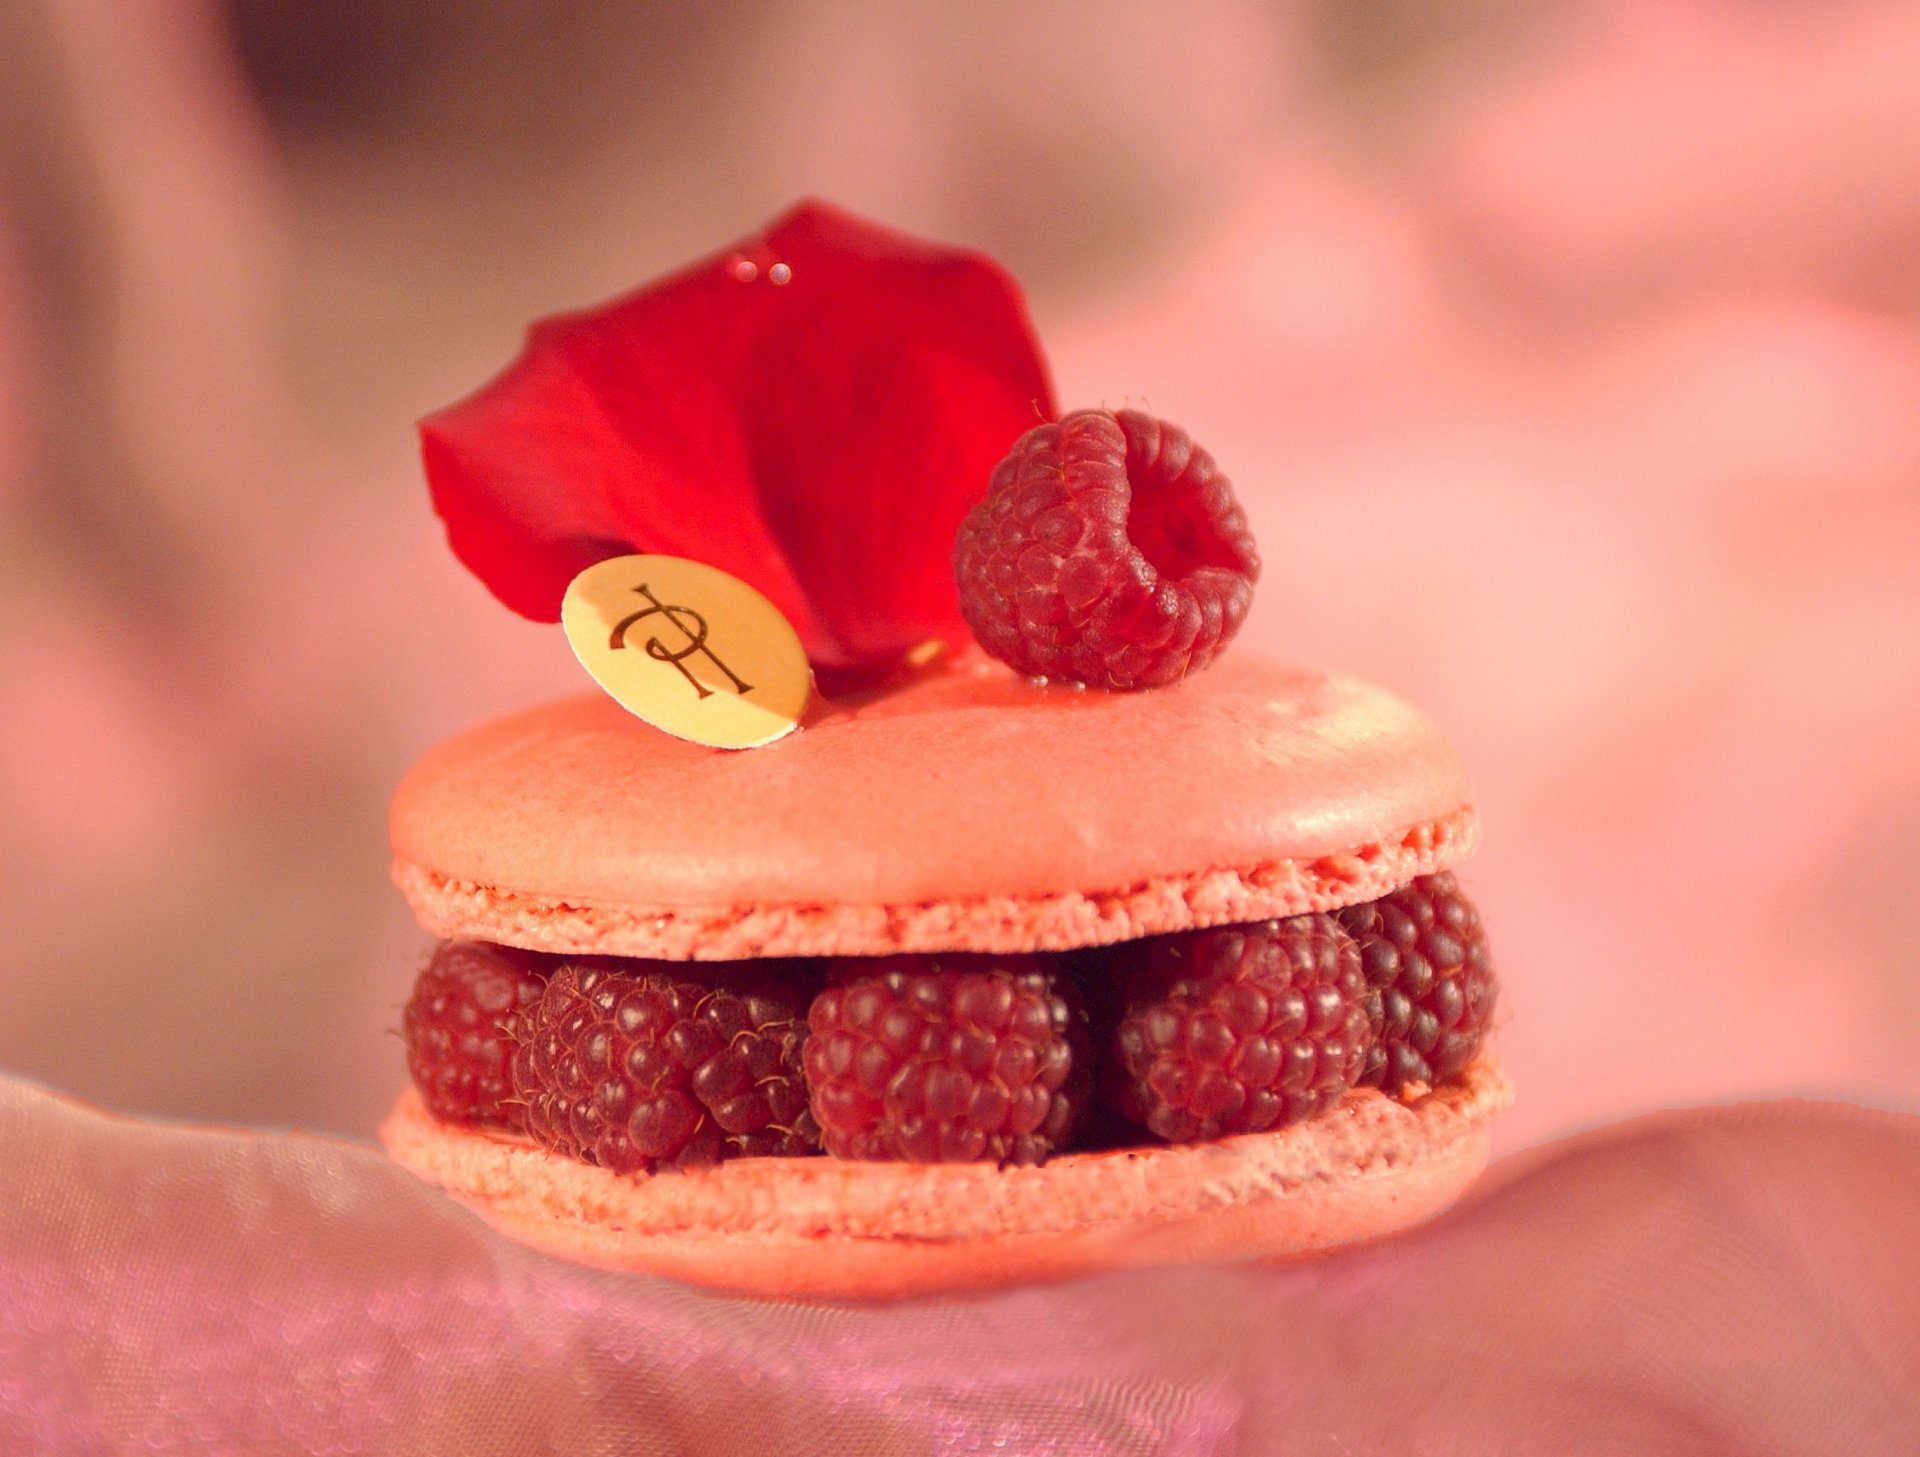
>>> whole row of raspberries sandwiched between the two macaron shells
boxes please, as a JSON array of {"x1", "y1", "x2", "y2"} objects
[{"x1": 403, "y1": 873, "x2": 1498, "y2": 1173}]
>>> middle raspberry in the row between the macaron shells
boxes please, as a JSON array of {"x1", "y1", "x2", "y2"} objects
[{"x1": 806, "y1": 954, "x2": 1089, "y2": 1163}]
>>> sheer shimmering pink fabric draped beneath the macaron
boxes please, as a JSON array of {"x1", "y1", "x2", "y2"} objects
[{"x1": 0, "y1": 1083, "x2": 1920, "y2": 1457}]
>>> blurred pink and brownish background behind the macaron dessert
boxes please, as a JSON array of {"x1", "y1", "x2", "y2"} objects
[{"x1": 0, "y1": 0, "x2": 1920, "y2": 1150}]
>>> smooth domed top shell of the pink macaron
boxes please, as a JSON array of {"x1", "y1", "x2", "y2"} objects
[{"x1": 392, "y1": 653, "x2": 1475, "y2": 960}]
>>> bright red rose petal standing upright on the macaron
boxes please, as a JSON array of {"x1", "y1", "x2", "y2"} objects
[{"x1": 420, "y1": 203, "x2": 1054, "y2": 674}]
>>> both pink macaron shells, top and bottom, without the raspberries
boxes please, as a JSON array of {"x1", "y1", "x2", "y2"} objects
[{"x1": 382, "y1": 653, "x2": 1511, "y2": 1300}]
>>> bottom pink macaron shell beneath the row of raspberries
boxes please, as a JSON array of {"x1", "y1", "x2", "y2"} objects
[{"x1": 380, "y1": 1056, "x2": 1511, "y2": 1300}]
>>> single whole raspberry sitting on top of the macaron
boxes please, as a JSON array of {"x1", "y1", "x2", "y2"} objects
[{"x1": 954, "y1": 411, "x2": 1260, "y2": 689}]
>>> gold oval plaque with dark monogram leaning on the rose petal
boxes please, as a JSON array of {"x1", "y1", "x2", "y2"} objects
[{"x1": 561, "y1": 555, "x2": 814, "y2": 749}]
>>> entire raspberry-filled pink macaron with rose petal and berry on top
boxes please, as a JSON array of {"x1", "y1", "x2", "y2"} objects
[{"x1": 382, "y1": 196, "x2": 1511, "y2": 1298}]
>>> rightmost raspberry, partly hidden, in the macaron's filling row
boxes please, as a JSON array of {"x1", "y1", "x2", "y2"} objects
[{"x1": 1338, "y1": 873, "x2": 1500, "y2": 1092}]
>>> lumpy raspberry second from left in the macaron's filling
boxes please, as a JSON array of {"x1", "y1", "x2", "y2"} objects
[{"x1": 513, "y1": 960, "x2": 820, "y2": 1173}]
